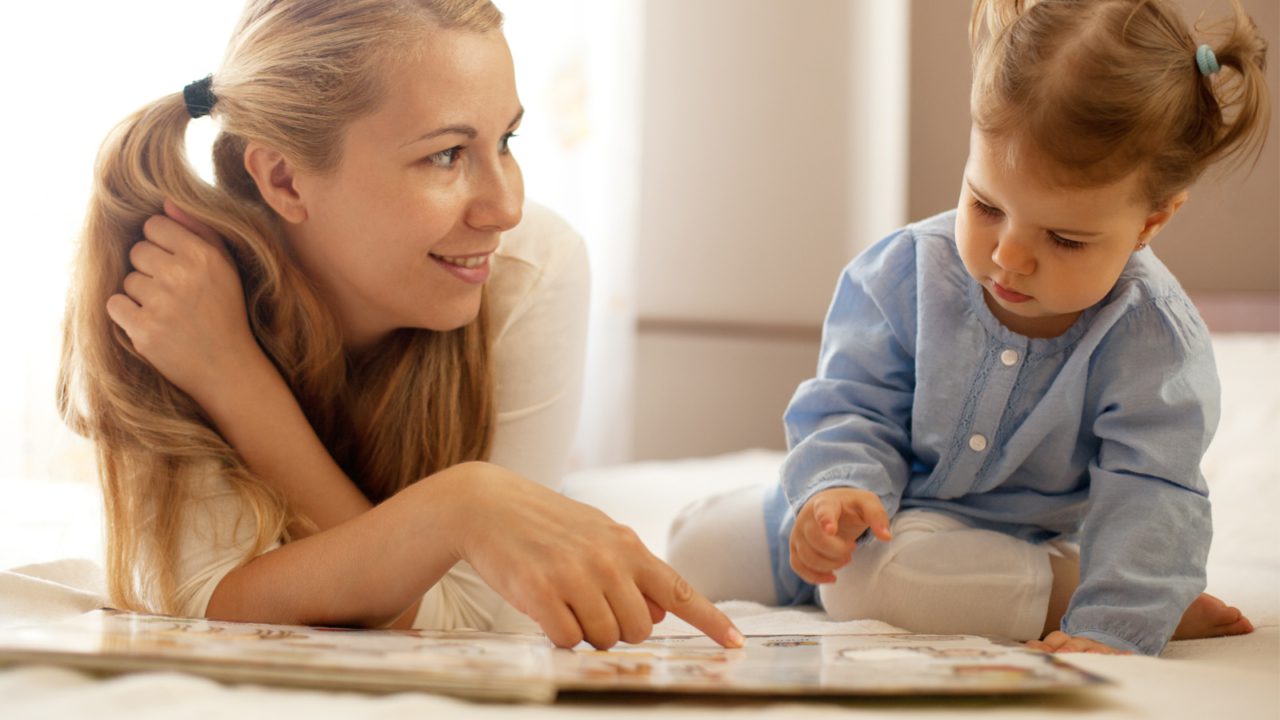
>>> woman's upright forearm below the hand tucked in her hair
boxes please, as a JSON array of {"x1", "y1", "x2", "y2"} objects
[{"x1": 195, "y1": 352, "x2": 372, "y2": 530}]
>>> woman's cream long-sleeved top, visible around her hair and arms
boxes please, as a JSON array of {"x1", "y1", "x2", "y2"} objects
[{"x1": 167, "y1": 204, "x2": 590, "y2": 628}]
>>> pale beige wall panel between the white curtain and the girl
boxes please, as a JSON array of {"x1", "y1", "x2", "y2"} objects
[{"x1": 632, "y1": 0, "x2": 908, "y2": 459}]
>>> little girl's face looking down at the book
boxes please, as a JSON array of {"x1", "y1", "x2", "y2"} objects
[{"x1": 956, "y1": 131, "x2": 1185, "y2": 337}]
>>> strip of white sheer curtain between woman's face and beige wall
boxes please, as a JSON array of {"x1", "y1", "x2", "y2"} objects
[{"x1": 500, "y1": 0, "x2": 644, "y2": 468}]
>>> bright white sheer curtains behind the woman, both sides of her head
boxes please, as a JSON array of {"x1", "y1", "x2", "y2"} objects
[{"x1": 0, "y1": 0, "x2": 640, "y2": 491}]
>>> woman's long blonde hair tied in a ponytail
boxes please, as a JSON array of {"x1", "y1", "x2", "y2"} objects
[{"x1": 58, "y1": 0, "x2": 502, "y2": 612}]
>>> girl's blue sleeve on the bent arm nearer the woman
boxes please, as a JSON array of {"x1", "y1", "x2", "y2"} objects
[{"x1": 782, "y1": 231, "x2": 916, "y2": 516}]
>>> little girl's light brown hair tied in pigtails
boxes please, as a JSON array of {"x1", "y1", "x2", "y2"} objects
[{"x1": 969, "y1": 0, "x2": 1270, "y2": 208}]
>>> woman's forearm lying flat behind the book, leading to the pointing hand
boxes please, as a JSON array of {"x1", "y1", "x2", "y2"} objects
[{"x1": 206, "y1": 470, "x2": 466, "y2": 626}]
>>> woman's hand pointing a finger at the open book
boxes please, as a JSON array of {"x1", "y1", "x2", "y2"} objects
[{"x1": 449, "y1": 462, "x2": 744, "y2": 648}]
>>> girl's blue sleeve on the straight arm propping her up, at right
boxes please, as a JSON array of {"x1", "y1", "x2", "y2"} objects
[{"x1": 1062, "y1": 299, "x2": 1219, "y2": 655}]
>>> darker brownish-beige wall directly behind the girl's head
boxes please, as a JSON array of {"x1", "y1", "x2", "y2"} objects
[{"x1": 908, "y1": 0, "x2": 1280, "y2": 293}]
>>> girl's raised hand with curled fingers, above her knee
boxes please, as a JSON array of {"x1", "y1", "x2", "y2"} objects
[{"x1": 791, "y1": 488, "x2": 892, "y2": 584}]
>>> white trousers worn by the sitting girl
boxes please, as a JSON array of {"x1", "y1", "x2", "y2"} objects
[{"x1": 668, "y1": 487, "x2": 1078, "y2": 641}]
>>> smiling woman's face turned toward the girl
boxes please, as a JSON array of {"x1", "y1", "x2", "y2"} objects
[{"x1": 289, "y1": 29, "x2": 525, "y2": 350}]
